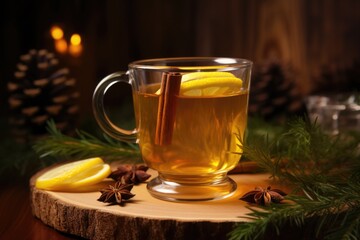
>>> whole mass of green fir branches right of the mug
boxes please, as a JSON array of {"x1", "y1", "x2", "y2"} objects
[{"x1": 229, "y1": 119, "x2": 360, "y2": 240}]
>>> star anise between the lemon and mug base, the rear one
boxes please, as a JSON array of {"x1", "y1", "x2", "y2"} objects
[{"x1": 109, "y1": 164, "x2": 151, "y2": 185}]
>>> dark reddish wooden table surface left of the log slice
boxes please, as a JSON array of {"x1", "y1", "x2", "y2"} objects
[{"x1": 0, "y1": 180, "x2": 79, "y2": 240}]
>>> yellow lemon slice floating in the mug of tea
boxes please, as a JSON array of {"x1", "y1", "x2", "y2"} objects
[{"x1": 180, "y1": 72, "x2": 242, "y2": 96}]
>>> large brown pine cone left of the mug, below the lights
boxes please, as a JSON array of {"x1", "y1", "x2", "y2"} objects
[{"x1": 7, "y1": 50, "x2": 79, "y2": 142}]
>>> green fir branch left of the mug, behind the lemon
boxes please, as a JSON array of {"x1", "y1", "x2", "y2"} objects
[{"x1": 33, "y1": 121, "x2": 141, "y2": 161}]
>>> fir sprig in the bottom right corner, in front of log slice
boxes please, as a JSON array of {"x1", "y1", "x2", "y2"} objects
[{"x1": 229, "y1": 183, "x2": 360, "y2": 240}]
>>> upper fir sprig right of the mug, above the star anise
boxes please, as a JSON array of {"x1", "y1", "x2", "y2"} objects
[{"x1": 244, "y1": 119, "x2": 360, "y2": 180}]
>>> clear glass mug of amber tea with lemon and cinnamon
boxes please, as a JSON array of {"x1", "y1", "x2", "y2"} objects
[{"x1": 93, "y1": 57, "x2": 252, "y2": 201}]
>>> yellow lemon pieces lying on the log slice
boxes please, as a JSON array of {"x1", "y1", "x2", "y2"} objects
[{"x1": 35, "y1": 158, "x2": 111, "y2": 191}]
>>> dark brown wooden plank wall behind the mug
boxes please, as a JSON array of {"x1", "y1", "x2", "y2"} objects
[{"x1": 0, "y1": 0, "x2": 360, "y2": 115}]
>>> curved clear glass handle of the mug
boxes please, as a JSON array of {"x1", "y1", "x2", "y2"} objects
[{"x1": 92, "y1": 72, "x2": 137, "y2": 142}]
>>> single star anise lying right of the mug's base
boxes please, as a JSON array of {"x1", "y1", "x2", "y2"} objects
[{"x1": 240, "y1": 186, "x2": 287, "y2": 206}]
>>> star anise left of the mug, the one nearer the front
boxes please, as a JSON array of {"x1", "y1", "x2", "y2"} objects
[{"x1": 98, "y1": 181, "x2": 135, "y2": 205}]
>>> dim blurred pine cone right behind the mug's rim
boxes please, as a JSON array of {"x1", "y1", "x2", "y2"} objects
[{"x1": 249, "y1": 63, "x2": 305, "y2": 120}]
